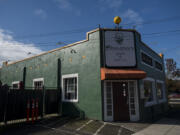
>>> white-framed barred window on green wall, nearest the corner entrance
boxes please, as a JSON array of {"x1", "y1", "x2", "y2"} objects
[{"x1": 63, "y1": 77, "x2": 78, "y2": 101}]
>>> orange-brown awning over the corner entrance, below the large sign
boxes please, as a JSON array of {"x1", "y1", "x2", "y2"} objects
[{"x1": 101, "y1": 68, "x2": 146, "y2": 80}]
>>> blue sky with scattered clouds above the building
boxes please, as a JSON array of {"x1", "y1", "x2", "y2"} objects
[{"x1": 0, "y1": 0, "x2": 180, "y2": 66}]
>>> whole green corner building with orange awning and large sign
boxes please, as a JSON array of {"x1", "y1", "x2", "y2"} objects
[{"x1": 0, "y1": 29, "x2": 168, "y2": 121}]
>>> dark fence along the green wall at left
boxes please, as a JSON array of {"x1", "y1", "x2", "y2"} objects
[{"x1": 0, "y1": 86, "x2": 61, "y2": 123}]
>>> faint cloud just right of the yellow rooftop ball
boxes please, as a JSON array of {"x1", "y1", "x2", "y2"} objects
[{"x1": 122, "y1": 9, "x2": 143, "y2": 27}]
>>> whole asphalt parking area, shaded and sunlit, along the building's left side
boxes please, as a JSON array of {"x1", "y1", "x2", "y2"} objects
[{"x1": 0, "y1": 117, "x2": 134, "y2": 135}]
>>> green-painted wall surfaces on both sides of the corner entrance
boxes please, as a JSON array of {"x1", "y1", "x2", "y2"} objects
[{"x1": 0, "y1": 30, "x2": 167, "y2": 120}]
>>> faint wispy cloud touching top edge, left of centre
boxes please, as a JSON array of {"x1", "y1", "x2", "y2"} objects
[{"x1": 54, "y1": 0, "x2": 81, "y2": 16}]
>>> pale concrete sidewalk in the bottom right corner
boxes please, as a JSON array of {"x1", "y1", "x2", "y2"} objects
[{"x1": 133, "y1": 118, "x2": 180, "y2": 135}]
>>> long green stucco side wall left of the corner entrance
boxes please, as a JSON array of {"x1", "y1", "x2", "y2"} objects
[{"x1": 1, "y1": 31, "x2": 102, "y2": 120}]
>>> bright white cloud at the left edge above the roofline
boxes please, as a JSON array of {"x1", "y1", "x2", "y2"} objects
[{"x1": 0, "y1": 29, "x2": 43, "y2": 66}]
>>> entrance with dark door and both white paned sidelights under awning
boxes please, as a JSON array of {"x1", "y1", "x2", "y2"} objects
[{"x1": 104, "y1": 80, "x2": 139, "y2": 121}]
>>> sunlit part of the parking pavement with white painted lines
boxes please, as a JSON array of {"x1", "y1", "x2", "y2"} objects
[{"x1": 39, "y1": 119, "x2": 134, "y2": 135}]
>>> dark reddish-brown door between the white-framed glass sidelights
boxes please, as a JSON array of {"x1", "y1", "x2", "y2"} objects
[{"x1": 112, "y1": 82, "x2": 130, "y2": 121}]
